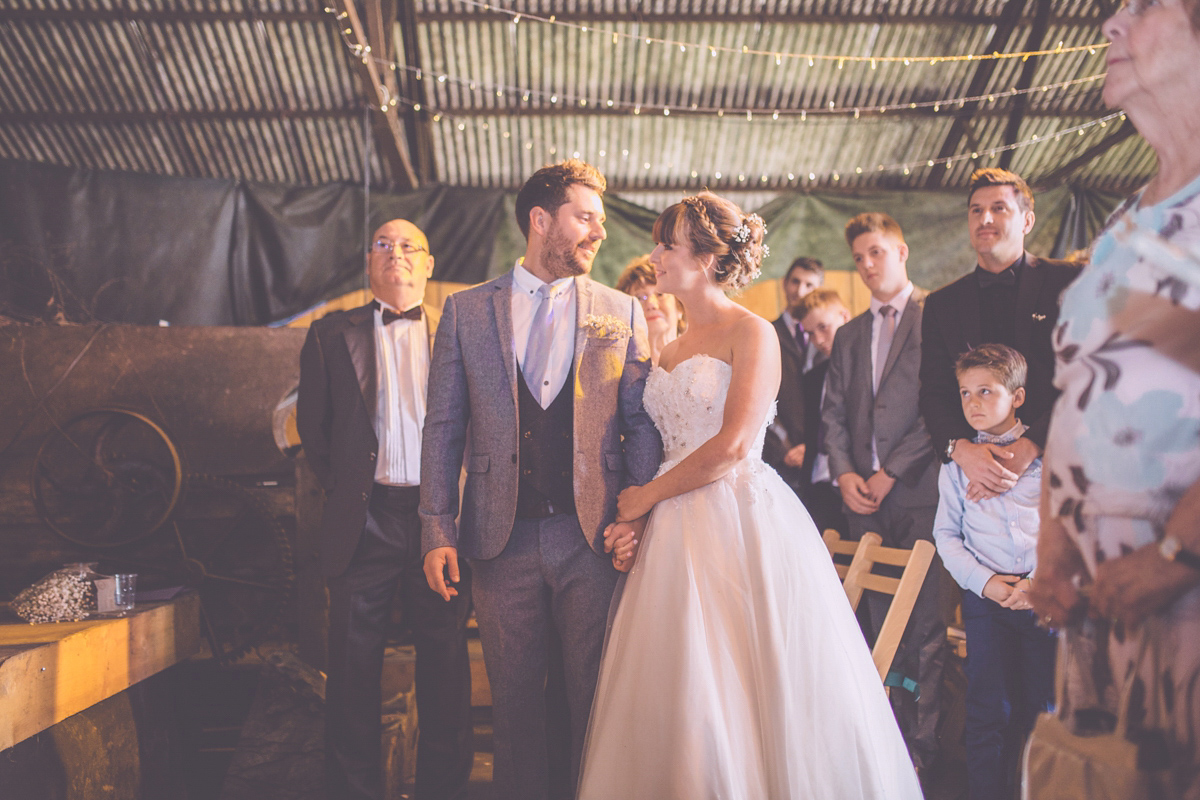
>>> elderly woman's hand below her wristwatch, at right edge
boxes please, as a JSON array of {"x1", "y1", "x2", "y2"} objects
[{"x1": 1091, "y1": 543, "x2": 1200, "y2": 627}]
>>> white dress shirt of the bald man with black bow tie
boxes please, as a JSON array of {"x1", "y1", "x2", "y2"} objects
[{"x1": 374, "y1": 300, "x2": 430, "y2": 486}]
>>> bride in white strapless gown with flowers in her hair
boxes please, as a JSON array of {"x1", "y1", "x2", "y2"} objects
[{"x1": 578, "y1": 192, "x2": 920, "y2": 800}]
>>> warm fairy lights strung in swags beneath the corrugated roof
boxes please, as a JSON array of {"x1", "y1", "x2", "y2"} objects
[{"x1": 325, "y1": 0, "x2": 1124, "y2": 185}]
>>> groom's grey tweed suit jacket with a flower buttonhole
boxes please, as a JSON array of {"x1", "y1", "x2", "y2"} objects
[{"x1": 420, "y1": 272, "x2": 662, "y2": 559}]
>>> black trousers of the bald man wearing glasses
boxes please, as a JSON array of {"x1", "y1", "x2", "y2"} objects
[{"x1": 325, "y1": 486, "x2": 474, "y2": 800}]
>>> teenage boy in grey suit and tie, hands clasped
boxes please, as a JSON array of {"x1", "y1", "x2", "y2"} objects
[{"x1": 821, "y1": 212, "x2": 946, "y2": 769}]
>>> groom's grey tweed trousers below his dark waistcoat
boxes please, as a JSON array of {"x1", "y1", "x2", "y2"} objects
[{"x1": 470, "y1": 515, "x2": 618, "y2": 800}]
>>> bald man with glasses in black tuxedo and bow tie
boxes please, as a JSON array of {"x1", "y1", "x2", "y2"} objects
[{"x1": 296, "y1": 219, "x2": 474, "y2": 800}]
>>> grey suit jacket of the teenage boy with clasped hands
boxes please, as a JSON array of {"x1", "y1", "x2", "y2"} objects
[{"x1": 821, "y1": 289, "x2": 940, "y2": 507}]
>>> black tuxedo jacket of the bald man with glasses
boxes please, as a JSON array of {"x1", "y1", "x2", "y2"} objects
[{"x1": 296, "y1": 303, "x2": 439, "y2": 577}]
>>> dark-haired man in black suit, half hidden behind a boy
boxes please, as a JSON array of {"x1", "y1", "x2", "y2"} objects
[{"x1": 762, "y1": 255, "x2": 824, "y2": 498}]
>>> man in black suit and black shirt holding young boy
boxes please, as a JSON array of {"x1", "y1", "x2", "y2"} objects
[{"x1": 919, "y1": 168, "x2": 1079, "y2": 500}]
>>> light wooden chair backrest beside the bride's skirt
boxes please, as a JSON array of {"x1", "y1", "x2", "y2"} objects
[{"x1": 842, "y1": 534, "x2": 937, "y2": 680}]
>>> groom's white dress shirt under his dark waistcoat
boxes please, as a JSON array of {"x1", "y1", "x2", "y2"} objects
[{"x1": 512, "y1": 261, "x2": 576, "y2": 408}]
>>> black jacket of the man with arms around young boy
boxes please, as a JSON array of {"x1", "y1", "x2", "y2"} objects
[{"x1": 920, "y1": 253, "x2": 1080, "y2": 461}]
